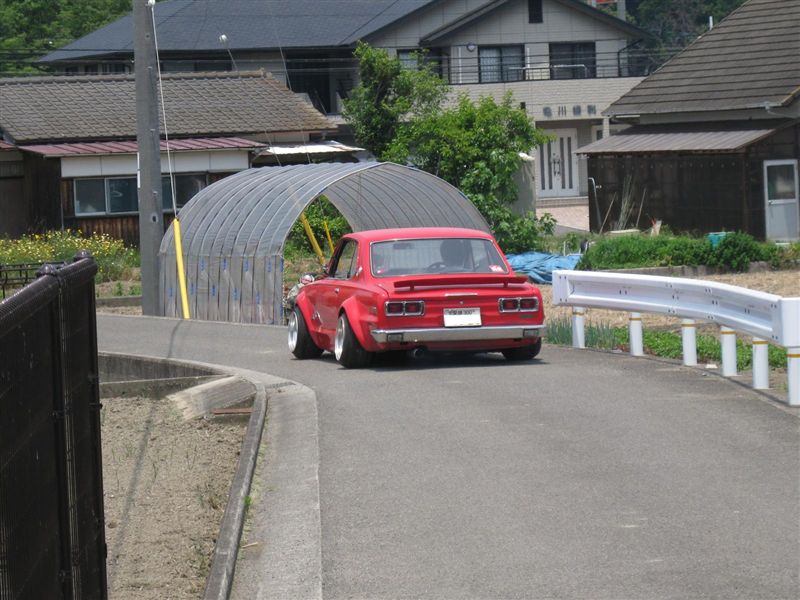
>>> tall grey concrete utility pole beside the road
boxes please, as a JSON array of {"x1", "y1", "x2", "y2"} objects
[{"x1": 133, "y1": 0, "x2": 164, "y2": 315}]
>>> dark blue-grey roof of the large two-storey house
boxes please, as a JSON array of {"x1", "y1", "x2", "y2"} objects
[{"x1": 42, "y1": 0, "x2": 437, "y2": 62}]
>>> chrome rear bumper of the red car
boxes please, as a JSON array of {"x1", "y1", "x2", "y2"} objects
[{"x1": 370, "y1": 325, "x2": 545, "y2": 344}]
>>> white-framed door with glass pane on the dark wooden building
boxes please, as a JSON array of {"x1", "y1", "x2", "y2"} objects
[{"x1": 764, "y1": 160, "x2": 800, "y2": 240}]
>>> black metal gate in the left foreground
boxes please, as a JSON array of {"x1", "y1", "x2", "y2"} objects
[{"x1": 0, "y1": 254, "x2": 108, "y2": 600}]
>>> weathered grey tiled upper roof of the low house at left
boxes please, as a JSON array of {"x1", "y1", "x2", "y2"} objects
[{"x1": 0, "y1": 72, "x2": 335, "y2": 144}]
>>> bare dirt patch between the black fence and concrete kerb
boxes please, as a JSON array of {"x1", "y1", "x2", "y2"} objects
[{"x1": 101, "y1": 398, "x2": 246, "y2": 600}]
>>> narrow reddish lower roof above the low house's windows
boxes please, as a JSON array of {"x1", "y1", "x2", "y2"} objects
[{"x1": 19, "y1": 138, "x2": 267, "y2": 157}]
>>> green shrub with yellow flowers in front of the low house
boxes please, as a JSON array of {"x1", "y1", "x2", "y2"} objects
[{"x1": 0, "y1": 229, "x2": 139, "y2": 282}]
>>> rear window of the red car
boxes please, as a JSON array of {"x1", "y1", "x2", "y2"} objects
[{"x1": 370, "y1": 238, "x2": 508, "y2": 277}]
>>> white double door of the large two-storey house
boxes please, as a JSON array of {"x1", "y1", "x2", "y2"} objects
[{"x1": 538, "y1": 129, "x2": 578, "y2": 198}]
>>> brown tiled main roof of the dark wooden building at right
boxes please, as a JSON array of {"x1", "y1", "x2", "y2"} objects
[{"x1": 605, "y1": 0, "x2": 800, "y2": 116}]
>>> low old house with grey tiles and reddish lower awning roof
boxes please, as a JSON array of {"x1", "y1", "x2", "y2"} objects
[{"x1": 0, "y1": 72, "x2": 338, "y2": 244}]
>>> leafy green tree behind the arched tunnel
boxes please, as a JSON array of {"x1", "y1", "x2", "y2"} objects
[{"x1": 344, "y1": 44, "x2": 553, "y2": 252}]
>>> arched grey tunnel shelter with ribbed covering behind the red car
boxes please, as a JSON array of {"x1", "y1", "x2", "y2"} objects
[{"x1": 159, "y1": 162, "x2": 489, "y2": 324}]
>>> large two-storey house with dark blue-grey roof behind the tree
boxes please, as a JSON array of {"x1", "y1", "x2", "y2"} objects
[{"x1": 42, "y1": 0, "x2": 653, "y2": 201}]
